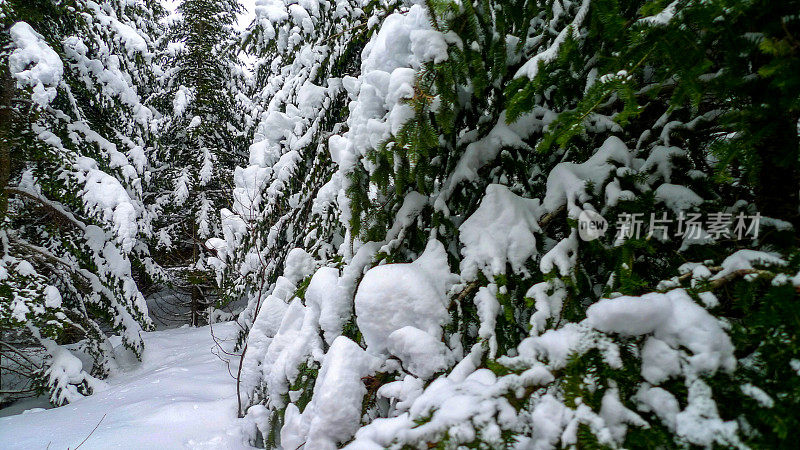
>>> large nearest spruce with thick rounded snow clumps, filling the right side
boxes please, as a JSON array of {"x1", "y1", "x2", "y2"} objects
[{"x1": 212, "y1": 0, "x2": 800, "y2": 449}]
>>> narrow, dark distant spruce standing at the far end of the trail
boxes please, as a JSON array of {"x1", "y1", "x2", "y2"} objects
[{"x1": 154, "y1": 0, "x2": 249, "y2": 325}]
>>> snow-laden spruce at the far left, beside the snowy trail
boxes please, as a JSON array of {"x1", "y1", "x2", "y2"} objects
[{"x1": 0, "y1": 0, "x2": 161, "y2": 404}]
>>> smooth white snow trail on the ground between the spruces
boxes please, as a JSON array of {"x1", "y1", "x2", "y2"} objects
[{"x1": 0, "y1": 322, "x2": 252, "y2": 450}]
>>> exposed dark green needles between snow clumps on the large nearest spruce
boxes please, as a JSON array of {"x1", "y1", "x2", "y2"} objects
[{"x1": 340, "y1": 0, "x2": 800, "y2": 448}]
